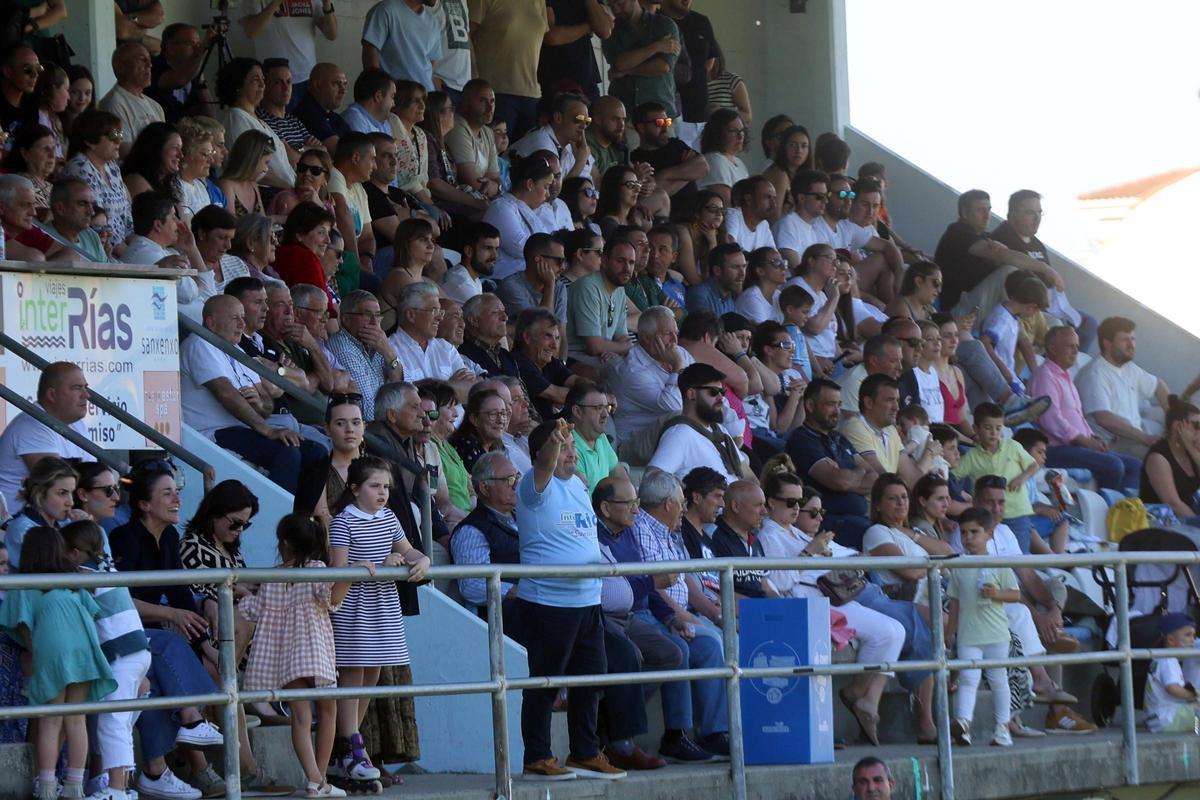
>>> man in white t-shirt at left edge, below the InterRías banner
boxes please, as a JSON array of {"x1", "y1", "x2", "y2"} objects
[{"x1": 0, "y1": 361, "x2": 96, "y2": 513}]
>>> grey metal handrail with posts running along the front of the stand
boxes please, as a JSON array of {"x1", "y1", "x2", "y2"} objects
[{"x1": 0, "y1": 556, "x2": 1200, "y2": 800}]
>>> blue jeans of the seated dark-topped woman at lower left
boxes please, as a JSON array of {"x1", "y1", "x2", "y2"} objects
[{"x1": 138, "y1": 627, "x2": 217, "y2": 760}]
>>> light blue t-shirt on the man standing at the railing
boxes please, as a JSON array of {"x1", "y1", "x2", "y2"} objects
[{"x1": 517, "y1": 470, "x2": 605, "y2": 608}]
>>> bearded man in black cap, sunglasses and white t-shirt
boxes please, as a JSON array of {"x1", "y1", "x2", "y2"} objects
[{"x1": 649, "y1": 363, "x2": 754, "y2": 483}]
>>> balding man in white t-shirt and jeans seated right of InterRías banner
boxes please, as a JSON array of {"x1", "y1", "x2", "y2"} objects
[{"x1": 179, "y1": 295, "x2": 326, "y2": 494}]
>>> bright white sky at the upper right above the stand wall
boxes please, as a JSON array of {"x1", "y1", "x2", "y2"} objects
[{"x1": 846, "y1": 0, "x2": 1200, "y2": 306}]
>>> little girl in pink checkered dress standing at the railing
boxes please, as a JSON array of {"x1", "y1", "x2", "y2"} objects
[{"x1": 238, "y1": 513, "x2": 357, "y2": 798}]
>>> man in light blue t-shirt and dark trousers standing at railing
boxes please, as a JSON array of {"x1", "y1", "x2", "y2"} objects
[{"x1": 516, "y1": 420, "x2": 625, "y2": 781}]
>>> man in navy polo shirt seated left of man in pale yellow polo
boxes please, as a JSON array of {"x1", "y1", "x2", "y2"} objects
[{"x1": 787, "y1": 378, "x2": 878, "y2": 548}]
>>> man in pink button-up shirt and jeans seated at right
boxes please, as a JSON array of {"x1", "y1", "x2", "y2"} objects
[{"x1": 1028, "y1": 325, "x2": 1141, "y2": 491}]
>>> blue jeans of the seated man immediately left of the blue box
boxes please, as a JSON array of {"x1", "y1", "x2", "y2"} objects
[{"x1": 634, "y1": 610, "x2": 730, "y2": 738}]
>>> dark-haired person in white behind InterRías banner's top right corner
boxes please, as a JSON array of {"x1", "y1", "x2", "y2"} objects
[{"x1": 121, "y1": 192, "x2": 216, "y2": 320}]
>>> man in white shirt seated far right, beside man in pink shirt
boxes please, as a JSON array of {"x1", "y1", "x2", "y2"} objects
[{"x1": 1075, "y1": 317, "x2": 1176, "y2": 458}]
